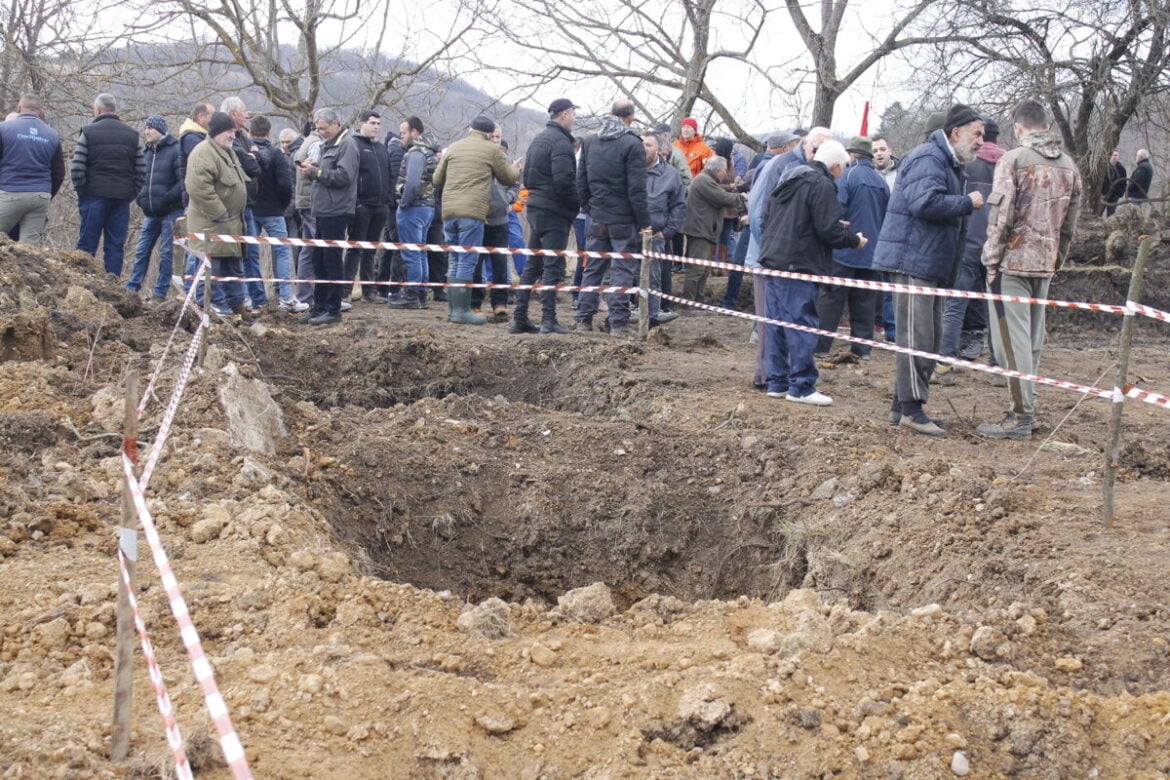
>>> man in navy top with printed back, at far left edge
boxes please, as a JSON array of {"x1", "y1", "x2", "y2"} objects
[{"x1": 0, "y1": 94, "x2": 66, "y2": 246}]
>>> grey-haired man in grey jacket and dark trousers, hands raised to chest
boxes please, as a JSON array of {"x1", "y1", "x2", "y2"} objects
[{"x1": 297, "y1": 109, "x2": 358, "y2": 325}]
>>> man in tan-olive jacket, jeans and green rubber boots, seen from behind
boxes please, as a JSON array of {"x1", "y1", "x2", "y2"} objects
[{"x1": 434, "y1": 113, "x2": 521, "y2": 325}]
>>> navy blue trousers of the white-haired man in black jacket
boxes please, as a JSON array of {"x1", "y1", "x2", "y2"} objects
[{"x1": 764, "y1": 276, "x2": 820, "y2": 398}]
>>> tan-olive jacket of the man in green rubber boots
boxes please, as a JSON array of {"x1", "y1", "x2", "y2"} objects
[{"x1": 434, "y1": 130, "x2": 519, "y2": 222}]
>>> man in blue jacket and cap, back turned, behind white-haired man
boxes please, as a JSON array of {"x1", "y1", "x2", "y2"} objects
[{"x1": 817, "y1": 136, "x2": 889, "y2": 360}]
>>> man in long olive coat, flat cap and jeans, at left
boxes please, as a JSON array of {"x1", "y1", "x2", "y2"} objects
[{"x1": 184, "y1": 111, "x2": 248, "y2": 316}]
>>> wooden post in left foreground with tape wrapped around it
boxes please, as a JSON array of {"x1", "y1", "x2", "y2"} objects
[{"x1": 110, "y1": 372, "x2": 138, "y2": 761}]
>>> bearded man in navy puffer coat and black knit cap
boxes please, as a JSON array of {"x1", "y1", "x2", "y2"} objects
[{"x1": 874, "y1": 103, "x2": 983, "y2": 436}]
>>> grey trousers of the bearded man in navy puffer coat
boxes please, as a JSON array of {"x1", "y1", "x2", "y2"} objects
[{"x1": 889, "y1": 274, "x2": 947, "y2": 403}]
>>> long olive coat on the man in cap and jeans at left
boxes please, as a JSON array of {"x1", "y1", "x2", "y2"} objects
[{"x1": 184, "y1": 138, "x2": 248, "y2": 257}]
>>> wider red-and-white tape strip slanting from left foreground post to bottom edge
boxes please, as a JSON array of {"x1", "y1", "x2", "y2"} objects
[{"x1": 122, "y1": 455, "x2": 252, "y2": 780}]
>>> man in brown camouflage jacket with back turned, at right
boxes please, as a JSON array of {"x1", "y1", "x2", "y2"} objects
[{"x1": 978, "y1": 101, "x2": 1083, "y2": 439}]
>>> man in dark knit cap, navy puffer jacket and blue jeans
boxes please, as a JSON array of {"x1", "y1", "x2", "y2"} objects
[{"x1": 126, "y1": 113, "x2": 187, "y2": 303}]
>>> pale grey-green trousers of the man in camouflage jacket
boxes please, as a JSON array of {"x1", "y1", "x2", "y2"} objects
[{"x1": 991, "y1": 274, "x2": 1052, "y2": 417}]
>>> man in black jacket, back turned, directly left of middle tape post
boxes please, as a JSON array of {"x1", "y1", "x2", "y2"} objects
[{"x1": 577, "y1": 99, "x2": 651, "y2": 338}]
